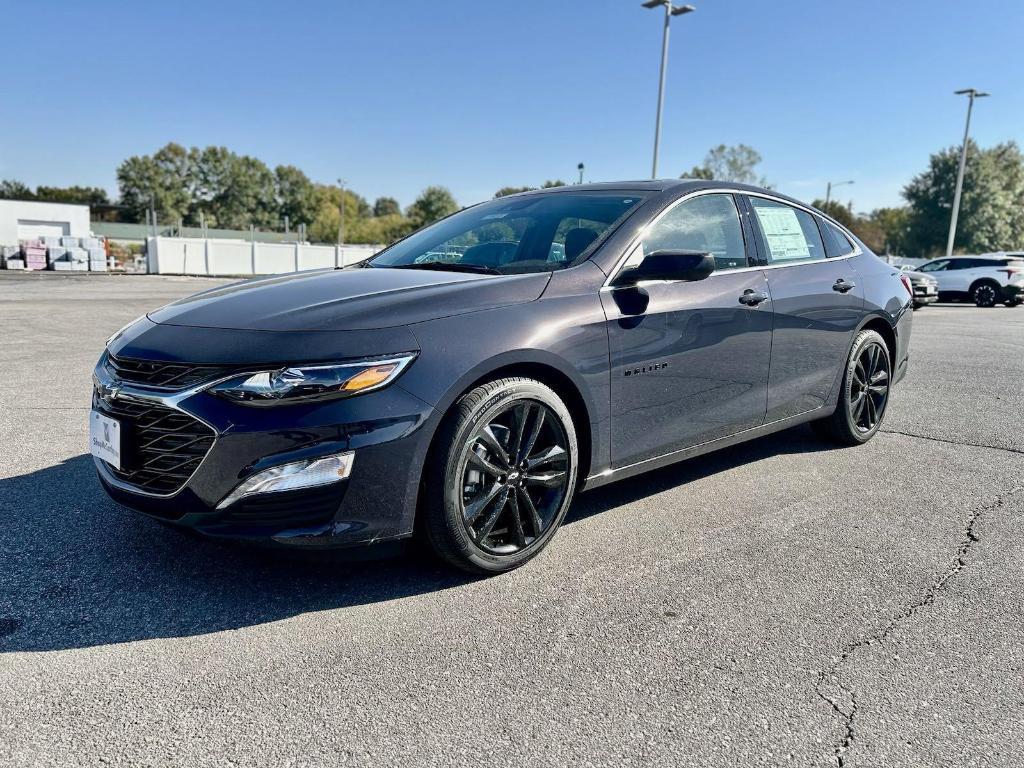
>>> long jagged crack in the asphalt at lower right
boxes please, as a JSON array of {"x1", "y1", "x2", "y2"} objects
[{"x1": 814, "y1": 489, "x2": 1021, "y2": 768}]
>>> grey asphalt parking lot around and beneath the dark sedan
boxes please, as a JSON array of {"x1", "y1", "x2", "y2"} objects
[{"x1": 0, "y1": 274, "x2": 1024, "y2": 766}]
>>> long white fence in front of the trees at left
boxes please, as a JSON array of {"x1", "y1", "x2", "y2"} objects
[{"x1": 146, "y1": 238, "x2": 383, "y2": 276}]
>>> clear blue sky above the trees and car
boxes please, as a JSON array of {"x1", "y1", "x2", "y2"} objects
[{"x1": 0, "y1": 0, "x2": 1024, "y2": 210}]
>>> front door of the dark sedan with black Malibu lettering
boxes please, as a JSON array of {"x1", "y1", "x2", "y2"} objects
[{"x1": 601, "y1": 194, "x2": 772, "y2": 468}]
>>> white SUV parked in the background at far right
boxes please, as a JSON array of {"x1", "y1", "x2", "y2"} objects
[{"x1": 918, "y1": 253, "x2": 1024, "y2": 306}]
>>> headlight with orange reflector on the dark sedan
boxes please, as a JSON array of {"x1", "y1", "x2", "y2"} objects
[{"x1": 210, "y1": 354, "x2": 416, "y2": 406}]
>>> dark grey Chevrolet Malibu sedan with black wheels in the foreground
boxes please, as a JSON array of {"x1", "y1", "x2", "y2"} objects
[{"x1": 90, "y1": 181, "x2": 911, "y2": 573}]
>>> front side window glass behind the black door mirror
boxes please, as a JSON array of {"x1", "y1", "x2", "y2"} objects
[{"x1": 627, "y1": 195, "x2": 746, "y2": 271}]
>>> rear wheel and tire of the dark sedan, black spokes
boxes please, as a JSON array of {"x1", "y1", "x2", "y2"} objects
[{"x1": 811, "y1": 329, "x2": 892, "y2": 445}]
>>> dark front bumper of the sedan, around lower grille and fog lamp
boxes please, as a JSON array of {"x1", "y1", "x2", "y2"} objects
[{"x1": 93, "y1": 362, "x2": 434, "y2": 547}]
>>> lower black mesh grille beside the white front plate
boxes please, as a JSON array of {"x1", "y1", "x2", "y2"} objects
[{"x1": 95, "y1": 398, "x2": 215, "y2": 494}]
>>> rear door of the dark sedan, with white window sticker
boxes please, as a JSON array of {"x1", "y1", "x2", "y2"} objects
[{"x1": 746, "y1": 196, "x2": 864, "y2": 423}]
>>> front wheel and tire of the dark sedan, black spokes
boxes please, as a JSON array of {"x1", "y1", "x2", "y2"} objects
[{"x1": 423, "y1": 377, "x2": 580, "y2": 574}]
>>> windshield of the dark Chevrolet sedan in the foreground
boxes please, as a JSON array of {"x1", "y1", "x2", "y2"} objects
[{"x1": 368, "y1": 191, "x2": 645, "y2": 274}]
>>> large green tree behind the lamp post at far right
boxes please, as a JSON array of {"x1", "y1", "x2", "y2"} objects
[{"x1": 903, "y1": 140, "x2": 1024, "y2": 256}]
